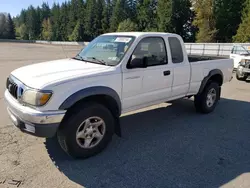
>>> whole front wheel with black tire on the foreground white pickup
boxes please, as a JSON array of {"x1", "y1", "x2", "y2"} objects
[{"x1": 57, "y1": 103, "x2": 115, "y2": 158}]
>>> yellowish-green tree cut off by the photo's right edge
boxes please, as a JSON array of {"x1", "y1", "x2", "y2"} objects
[{"x1": 233, "y1": 0, "x2": 250, "y2": 43}]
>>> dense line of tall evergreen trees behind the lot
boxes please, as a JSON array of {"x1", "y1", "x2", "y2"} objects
[{"x1": 0, "y1": 0, "x2": 250, "y2": 42}]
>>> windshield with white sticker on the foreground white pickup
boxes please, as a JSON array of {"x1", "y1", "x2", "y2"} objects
[{"x1": 75, "y1": 35, "x2": 134, "y2": 66}]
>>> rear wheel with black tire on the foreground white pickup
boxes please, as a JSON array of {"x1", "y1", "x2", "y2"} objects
[{"x1": 194, "y1": 82, "x2": 220, "y2": 114}]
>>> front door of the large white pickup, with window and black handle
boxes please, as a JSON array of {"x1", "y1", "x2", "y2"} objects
[{"x1": 123, "y1": 36, "x2": 173, "y2": 109}]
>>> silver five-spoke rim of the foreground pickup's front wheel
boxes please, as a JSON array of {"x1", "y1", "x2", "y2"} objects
[{"x1": 76, "y1": 117, "x2": 106, "y2": 149}]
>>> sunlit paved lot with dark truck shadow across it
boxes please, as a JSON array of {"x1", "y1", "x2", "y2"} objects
[{"x1": 0, "y1": 43, "x2": 250, "y2": 188}]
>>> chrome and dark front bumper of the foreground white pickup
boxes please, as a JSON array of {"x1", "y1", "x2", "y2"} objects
[{"x1": 4, "y1": 90, "x2": 66, "y2": 138}]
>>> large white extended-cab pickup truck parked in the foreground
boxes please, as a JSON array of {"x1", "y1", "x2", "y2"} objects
[{"x1": 5, "y1": 32, "x2": 233, "y2": 158}]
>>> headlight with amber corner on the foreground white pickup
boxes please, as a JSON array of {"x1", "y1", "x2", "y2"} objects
[{"x1": 22, "y1": 89, "x2": 52, "y2": 106}]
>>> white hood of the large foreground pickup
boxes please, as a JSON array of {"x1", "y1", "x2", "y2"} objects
[{"x1": 11, "y1": 59, "x2": 111, "y2": 89}]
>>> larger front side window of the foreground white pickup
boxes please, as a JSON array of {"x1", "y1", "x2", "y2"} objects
[{"x1": 128, "y1": 37, "x2": 168, "y2": 68}]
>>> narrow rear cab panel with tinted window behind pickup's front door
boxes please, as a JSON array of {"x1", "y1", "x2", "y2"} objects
[{"x1": 168, "y1": 37, "x2": 191, "y2": 98}]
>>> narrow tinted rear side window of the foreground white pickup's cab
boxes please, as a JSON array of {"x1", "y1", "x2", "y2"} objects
[{"x1": 168, "y1": 37, "x2": 184, "y2": 63}]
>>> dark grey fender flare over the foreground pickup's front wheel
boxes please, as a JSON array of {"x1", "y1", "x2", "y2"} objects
[{"x1": 59, "y1": 86, "x2": 121, "y2": 115}]
